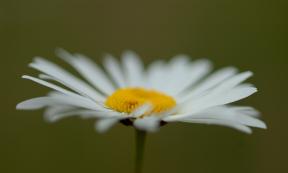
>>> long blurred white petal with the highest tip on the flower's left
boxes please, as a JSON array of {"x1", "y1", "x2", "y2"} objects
[{"x1": 56, "y1": 49, "x2": 115, "y2": 95}]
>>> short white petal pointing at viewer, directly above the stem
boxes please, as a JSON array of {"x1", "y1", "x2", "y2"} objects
[{"x1": 133, "y1": 116, "x2": 160, "y2": 132}]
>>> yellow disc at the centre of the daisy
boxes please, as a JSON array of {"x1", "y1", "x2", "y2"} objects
[{"x1": 105, "y1": 88, "x2": 176, "y2": 113}]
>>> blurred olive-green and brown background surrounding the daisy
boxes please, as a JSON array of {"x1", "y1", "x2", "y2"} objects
[{"x1": 0, "y1": 0, "x2": 288, "y2": 173}]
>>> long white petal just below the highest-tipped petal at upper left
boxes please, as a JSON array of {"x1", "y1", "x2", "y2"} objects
[{"x1": 30, "y1": 58, "x2": 105, "y2": 102}]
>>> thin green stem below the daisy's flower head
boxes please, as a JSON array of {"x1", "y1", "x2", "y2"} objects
[{"x1": 135, "y1": 129, "x2": 146, "y2": 173}]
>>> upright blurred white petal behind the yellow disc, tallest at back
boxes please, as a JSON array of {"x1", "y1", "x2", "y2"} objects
[{"x1": 122, "y1": 51, "x2": 145, "y2": 87}]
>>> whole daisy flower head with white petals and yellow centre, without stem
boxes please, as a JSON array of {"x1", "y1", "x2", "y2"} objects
[{"x1": 17, "y1": 49, "x2": 266, "y2": 133}]
